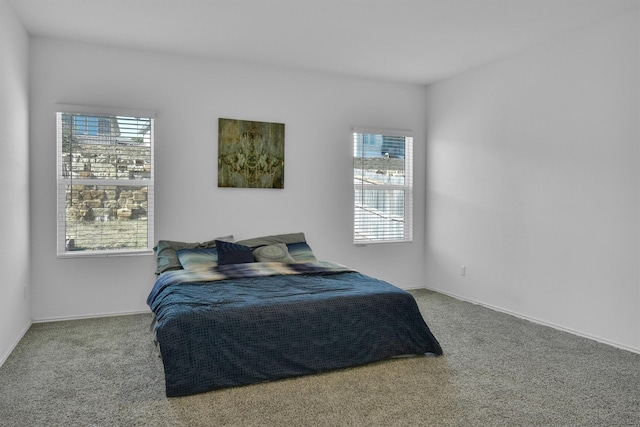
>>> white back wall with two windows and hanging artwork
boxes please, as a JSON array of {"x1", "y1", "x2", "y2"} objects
[{"x1": 31, "y1": 38, "x2": 426, "y2": 320}]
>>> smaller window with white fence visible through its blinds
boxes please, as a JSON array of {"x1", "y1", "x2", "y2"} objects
[{"x1": 353, "y1": 129, "x2": 413, "y2": 244}]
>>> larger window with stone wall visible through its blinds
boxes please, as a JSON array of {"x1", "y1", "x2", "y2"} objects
[{"x1": 56, "y1": 106, "x2": 154, "y2": 257}]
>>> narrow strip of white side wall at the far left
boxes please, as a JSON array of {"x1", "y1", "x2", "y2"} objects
[{"x1": 0, "y1": 0, "x2": 31, "y2": 365}]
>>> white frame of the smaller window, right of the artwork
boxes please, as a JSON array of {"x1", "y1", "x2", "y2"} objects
[{"x1": 351, "y1": 126, "x2": 415, "y2": 246}]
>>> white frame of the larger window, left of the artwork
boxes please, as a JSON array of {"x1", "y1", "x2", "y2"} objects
[{"x1": 54, "y1": 104, "x2": 156, "y2": 258}]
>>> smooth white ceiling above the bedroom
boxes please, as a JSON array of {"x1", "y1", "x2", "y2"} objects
[{"x1": 9, "y1": 0, "x2": 640, "y2": 84}]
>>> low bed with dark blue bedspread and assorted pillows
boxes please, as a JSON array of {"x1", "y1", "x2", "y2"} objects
[{"x1": 147, "y1": 233, "x2": 442, "y2": 397}]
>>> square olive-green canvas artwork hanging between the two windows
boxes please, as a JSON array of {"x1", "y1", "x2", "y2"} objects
[{"x1": 218, "y1": 118, "x2": 284, "y2": 188}]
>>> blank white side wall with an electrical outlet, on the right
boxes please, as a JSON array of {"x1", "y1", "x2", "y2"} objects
[{"x1": 426, "y1": 11, "x2": 640, "y2": 351}]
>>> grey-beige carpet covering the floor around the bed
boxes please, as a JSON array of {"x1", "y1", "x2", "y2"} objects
[{"x1": 0, "y1": 290, "x2": 640, "y2": 426}]
